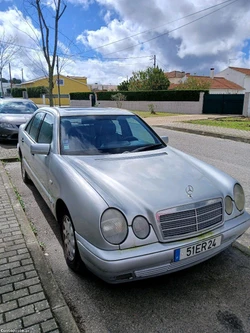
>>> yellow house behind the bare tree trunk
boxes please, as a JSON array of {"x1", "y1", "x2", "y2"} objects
[{"x1": 19, "y1": 74, "x2": 91, "y2": 105}]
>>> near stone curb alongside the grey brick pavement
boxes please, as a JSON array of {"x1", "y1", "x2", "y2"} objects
[{"x1": 0, "y1": 163, "x2": 80, "y2": 333}]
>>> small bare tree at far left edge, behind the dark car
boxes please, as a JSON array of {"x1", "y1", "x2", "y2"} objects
[{"x1": 0, "y1": 30, "x2": 20, "y2": 96}]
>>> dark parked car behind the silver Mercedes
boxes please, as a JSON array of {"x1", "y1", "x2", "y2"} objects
[{"x1": 0, "y1": 98, "x2": 38, "y2": 140}]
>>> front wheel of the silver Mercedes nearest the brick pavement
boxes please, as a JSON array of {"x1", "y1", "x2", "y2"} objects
[{"x1": 60, "y1": 209, "x2": 86, "y2": 273}]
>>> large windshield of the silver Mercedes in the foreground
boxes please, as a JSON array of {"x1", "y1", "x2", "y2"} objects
[{"x1": 60, "y1": 115, "x2": 165, "y2": 155}]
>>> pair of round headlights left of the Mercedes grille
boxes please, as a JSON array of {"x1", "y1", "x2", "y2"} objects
[{"x1": 101, "y1": 208, "x2": 150, "y2": 245}]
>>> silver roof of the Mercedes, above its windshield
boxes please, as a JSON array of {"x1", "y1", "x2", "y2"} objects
[{"x1": 37, "y1": 107, "x2": 134, "y2": 117}]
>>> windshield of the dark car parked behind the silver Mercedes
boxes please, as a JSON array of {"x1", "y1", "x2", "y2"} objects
[{"x1": 0, "y1": 101, "x2": 38, "y2": 114}]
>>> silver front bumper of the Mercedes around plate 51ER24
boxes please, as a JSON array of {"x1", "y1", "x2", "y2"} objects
[{"x1": 76, "y1": 212, "x2": 250, "y2": 283}]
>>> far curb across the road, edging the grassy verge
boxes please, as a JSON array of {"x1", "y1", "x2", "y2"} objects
[{"x1": 154, "y1": 125, "x2": 250, "y2": 143}]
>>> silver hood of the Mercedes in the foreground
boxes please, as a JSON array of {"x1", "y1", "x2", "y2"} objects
[{"x1": 65, "y1": 148, "x2": 223, "y2": 213}]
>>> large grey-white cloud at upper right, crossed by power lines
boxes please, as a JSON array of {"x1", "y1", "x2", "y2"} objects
[{"x1": 78, "y1": 0, "x2": 250, "y2": 76}]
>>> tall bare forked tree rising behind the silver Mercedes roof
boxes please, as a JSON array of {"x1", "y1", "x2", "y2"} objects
[{"x1": 30, "y1": 0, "x2": 67, "y2": 106}]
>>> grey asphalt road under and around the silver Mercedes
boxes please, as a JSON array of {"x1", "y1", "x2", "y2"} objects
[{"x1": 1, "y1": 129, "x2": 250, "y2": 333}]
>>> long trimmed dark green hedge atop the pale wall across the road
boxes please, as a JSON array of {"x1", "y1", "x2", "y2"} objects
[{"x1": 70, "y1": 90, "x2": 208, "y2": 101}]
